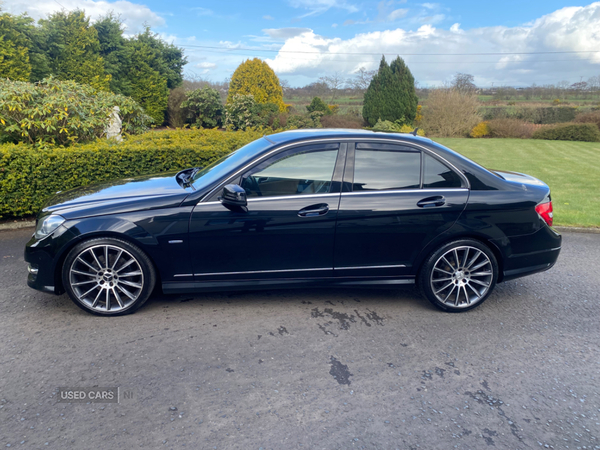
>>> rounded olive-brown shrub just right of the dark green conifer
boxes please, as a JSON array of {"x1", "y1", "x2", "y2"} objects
[{"x1": 421, "y1": 89, "x2": 481, "y2": 137}]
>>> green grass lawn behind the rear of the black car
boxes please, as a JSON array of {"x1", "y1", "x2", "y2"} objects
[{"x1": 435, "y1": 138, "x2": 600, "y2": 227}]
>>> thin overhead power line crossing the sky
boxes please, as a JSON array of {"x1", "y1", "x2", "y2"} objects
[{"x1": 181, "y1": 44, "x2": 600, "y2": 56}]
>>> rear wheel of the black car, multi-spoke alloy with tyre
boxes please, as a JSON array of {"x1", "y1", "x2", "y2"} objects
[{"x1": 418, "y1": 239, "x2": 498, "y2": 312}]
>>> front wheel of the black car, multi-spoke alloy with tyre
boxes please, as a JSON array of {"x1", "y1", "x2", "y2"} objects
[{"x1": 62, "y1": 238, "x2": 156, "y2": 316}]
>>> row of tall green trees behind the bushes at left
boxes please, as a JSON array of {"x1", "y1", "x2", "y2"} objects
[{"x1": 0, "y1": 10, "x2": 187, "y2": 125}]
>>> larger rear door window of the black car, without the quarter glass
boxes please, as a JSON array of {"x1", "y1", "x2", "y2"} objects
[{"x1": 352, "y1": 149, "x2": 421, "y2": 192}]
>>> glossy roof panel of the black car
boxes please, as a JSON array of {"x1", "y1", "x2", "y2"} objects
[{"x1": 265, "y1": 128, "x2": 431, "y2": 144}]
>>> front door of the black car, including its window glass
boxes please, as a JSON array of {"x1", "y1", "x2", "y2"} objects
[{"x1": 190, "y1": 143, "x2": 345, "y2": 282}]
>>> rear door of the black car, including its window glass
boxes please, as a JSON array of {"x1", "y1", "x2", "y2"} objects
[{"x1": 334, "y1": 142, "x2": 469, "y2": 277}]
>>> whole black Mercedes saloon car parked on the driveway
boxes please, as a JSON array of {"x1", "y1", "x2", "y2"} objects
[{"x1": 25, "y1": 130, "x2": 561, "y2": 316}]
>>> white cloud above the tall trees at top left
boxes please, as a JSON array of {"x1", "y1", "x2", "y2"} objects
[{"x1": 2, "y1": 0, "x2": 165, "y2": 34}]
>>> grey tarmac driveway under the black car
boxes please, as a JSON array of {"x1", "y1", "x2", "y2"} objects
[{"x1": 0, "y1": 229, "x2": 600, "y2": 450}]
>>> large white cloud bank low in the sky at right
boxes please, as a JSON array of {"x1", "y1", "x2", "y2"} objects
[{"x1": 266, "y1": 2, "x2": 600, "y2": 85}]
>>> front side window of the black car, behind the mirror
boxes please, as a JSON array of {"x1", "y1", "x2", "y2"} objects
[{"x1": 242, "y1": 150, "x2": 338, "y2": 198}]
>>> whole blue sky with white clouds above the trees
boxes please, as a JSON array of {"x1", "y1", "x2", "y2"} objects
[{"x1": 0, "y1": 0, "x2": 600, "y2": 87}]
